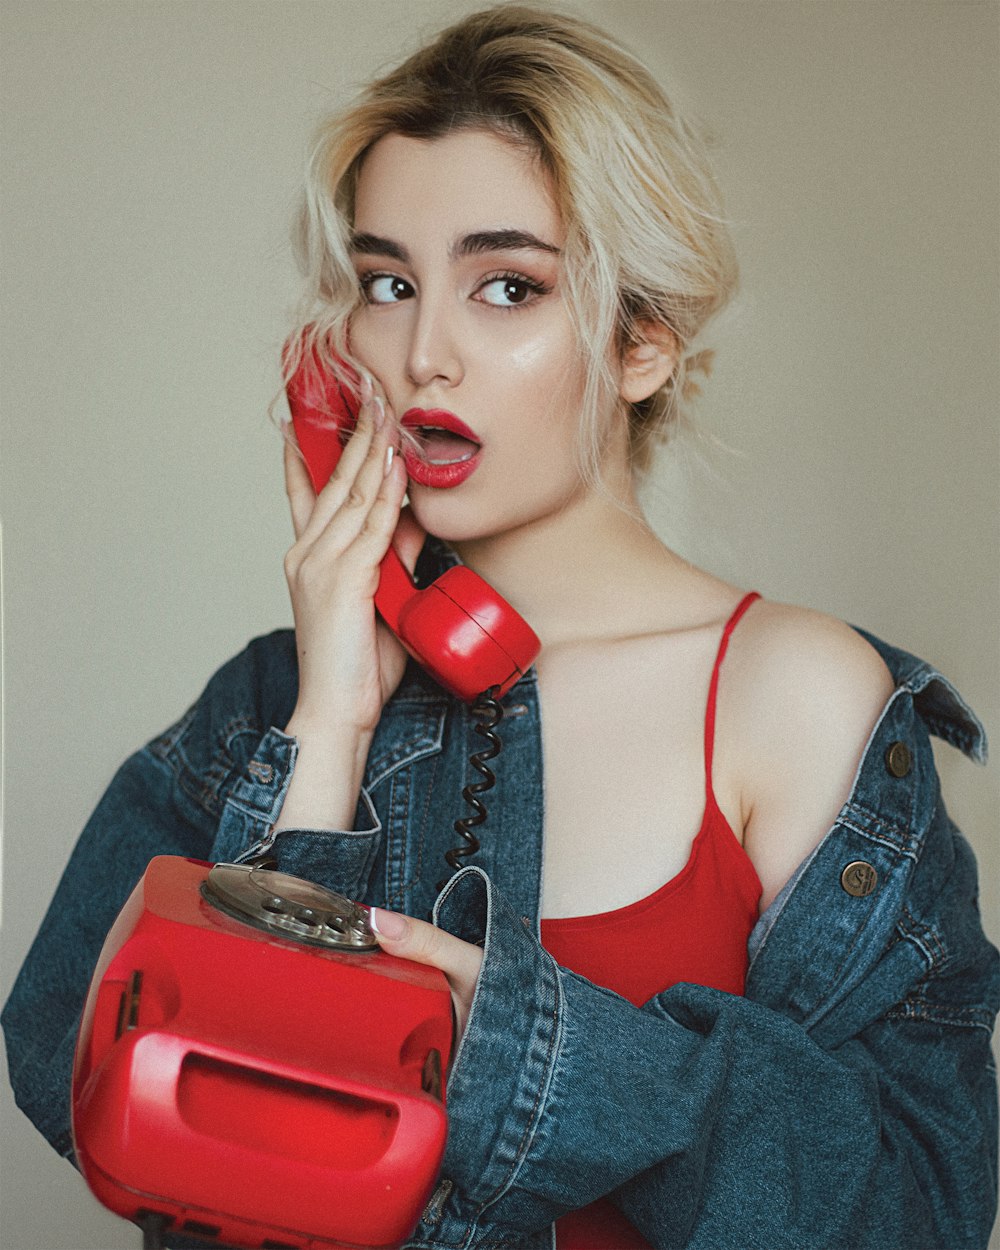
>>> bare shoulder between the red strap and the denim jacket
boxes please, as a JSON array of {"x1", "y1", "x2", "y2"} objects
[{"x1": 720, "y1": 601, "x2": 893, "y2": 906}]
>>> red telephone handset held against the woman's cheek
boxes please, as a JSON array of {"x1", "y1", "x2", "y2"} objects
[{"x1": 286, "y1": 351, "x2": 541, "y2": 703}]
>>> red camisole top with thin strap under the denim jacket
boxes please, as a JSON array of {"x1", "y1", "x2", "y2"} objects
[{"x1": 541, "y1": 594, "x2": 761, "y2": 1250}]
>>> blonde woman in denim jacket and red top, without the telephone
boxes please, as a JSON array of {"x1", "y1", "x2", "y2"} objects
[{"x1": 6, "y1": 5, "x2": 996, "y2": 1248}]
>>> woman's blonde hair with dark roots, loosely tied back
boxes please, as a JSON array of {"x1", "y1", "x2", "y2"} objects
[{"x1": 289, "y1": 4, "x2": 736, "y2": 481}]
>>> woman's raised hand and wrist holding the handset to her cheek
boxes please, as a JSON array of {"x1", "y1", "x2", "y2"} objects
[{"x1": 275, "y1": 388, "x2": 424, "y2": 829}]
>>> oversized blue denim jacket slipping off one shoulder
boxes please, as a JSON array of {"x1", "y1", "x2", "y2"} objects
[{"x1": 4, "y1": 560, "x2": 999, "y2": 1250}]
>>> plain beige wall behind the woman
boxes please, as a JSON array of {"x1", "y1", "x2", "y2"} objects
[{"x1": 0, "y1": 0, "x2": 1000, "y2": 1250}]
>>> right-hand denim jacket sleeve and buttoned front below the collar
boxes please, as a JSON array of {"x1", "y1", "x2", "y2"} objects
[{"x1": 414, "y1": 660, "x2": 998, "y2": 1250}]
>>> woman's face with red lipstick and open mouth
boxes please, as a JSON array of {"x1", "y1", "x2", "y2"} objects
[{"x1": 350, "y1": 130, "x2": 620, "y2": 541}]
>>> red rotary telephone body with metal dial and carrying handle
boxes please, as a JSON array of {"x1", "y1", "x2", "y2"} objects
[{"x1": 73, "y1": 855, "x2": 453, "y2": 1250}]
